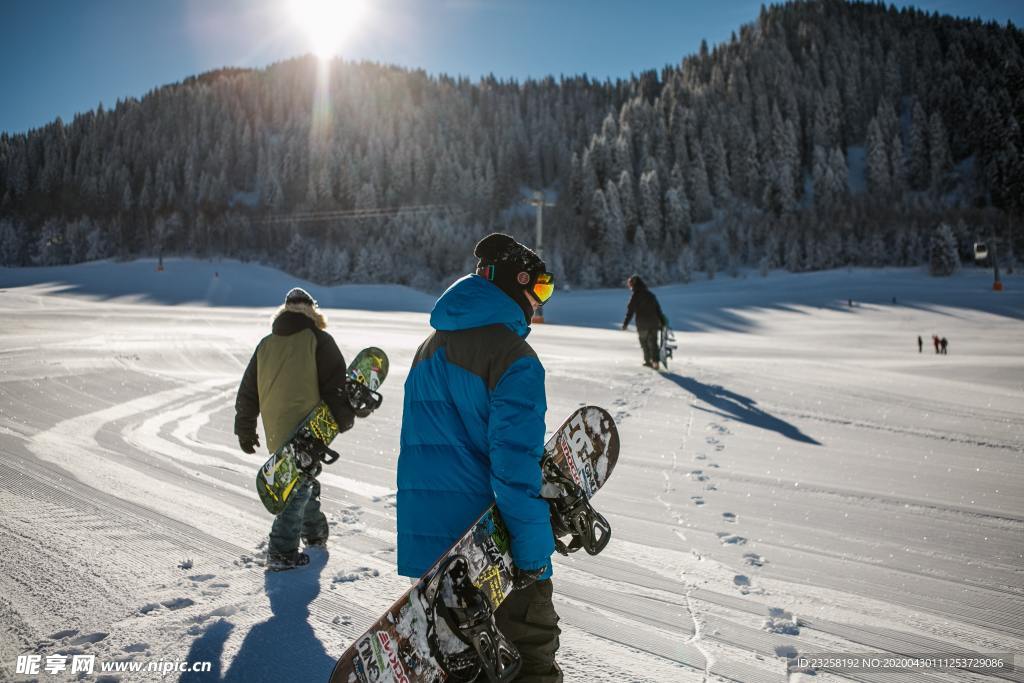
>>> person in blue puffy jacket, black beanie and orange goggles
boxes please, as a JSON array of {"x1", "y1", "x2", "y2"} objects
[{"x1": 397, "y1": 232, "x2": 562, "y2": 683}]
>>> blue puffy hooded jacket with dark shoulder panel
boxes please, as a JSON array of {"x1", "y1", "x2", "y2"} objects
[{"x1": 397, "y1": 275, "x2": 554, "y2": 579}]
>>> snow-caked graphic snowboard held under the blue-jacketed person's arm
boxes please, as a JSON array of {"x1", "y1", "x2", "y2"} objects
[{"x1": 331, "y1": 405, "x2": 618, "y2": 683}]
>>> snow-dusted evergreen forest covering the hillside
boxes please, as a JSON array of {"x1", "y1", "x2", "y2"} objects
[{"x1": 0, "y1": 0, "x2": 1024, "y2": 289}]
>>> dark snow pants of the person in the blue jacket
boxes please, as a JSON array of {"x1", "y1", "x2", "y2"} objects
[{"x1": 495, "y1": 579, "x2": 562, "y2": 683}]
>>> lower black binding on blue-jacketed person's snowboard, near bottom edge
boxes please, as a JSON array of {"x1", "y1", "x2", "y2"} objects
[{"x1": 424, "y1": 554, "x2": 522, "y2": 683}]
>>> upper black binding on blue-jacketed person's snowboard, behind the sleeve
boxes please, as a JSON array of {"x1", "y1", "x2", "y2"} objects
[{"x1": 541, "y1": 458, "x2": 611, "y2": 555}]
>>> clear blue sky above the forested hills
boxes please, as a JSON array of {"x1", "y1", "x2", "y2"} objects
[{"x1": 0, "y1": 0, "x2": 1024, "y2": 132}]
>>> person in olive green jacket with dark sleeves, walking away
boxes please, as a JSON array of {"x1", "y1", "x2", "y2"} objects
[{"x1": 234, "y1": 288, "x2": 355, "y2": 571}]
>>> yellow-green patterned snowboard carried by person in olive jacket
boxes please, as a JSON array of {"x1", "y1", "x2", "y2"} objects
[{"x1": 256, "y1": 346, "x2": 388, "y2": 515}]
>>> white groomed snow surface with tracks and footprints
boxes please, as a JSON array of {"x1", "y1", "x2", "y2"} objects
[{"x1": 0, "y1": 260, "x2": 1024, "y2": 682}]
